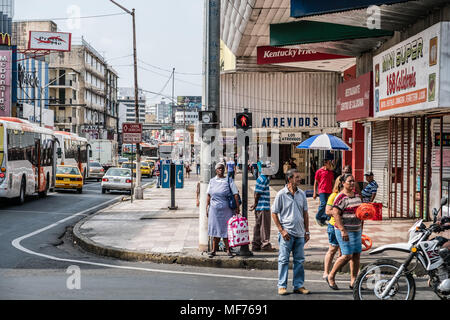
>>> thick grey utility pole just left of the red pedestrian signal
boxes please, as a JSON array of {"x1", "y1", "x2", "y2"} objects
[{"x1": 199, "y1": 0, "x2": 220, "y2": 251}]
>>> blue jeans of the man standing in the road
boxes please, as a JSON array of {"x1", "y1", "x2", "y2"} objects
[{"x1": 278, "y1": 233, "x2": 305, "y2": 290}]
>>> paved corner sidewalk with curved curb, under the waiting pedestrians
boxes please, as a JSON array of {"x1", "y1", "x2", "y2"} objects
[{"x1": 73, "y1": 174, "x2": 413, "y2": 271}]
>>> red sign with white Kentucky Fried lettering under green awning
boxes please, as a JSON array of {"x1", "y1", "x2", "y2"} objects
[{"x1": 257, "y1": 46, "x2": 352, "y2": 64}]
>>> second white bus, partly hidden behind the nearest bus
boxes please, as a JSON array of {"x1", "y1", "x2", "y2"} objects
[{"x1": 55, "y1": 131, "x2": 92, "y2": 182}]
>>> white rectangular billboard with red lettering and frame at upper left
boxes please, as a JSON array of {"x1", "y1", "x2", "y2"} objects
[{"x1": 28, "y1": 31, "x2": 72, "y2": 51}]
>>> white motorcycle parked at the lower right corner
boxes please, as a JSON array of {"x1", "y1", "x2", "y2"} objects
[{"x1": 353, "y1": 198, "x2": 450, "y2": 300}]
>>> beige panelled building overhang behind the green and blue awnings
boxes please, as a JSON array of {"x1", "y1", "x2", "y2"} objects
[{"x1": 221, "y1": 0, "x2": 448, "y2": 57}]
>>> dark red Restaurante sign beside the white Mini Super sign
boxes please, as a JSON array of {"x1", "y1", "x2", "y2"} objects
[{"x1": 336, "y1": 72, "x2": 373, "y2": 122}]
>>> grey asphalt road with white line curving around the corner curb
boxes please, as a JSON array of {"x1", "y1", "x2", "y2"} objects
[{"x1": 0, "y1": 182, "x2": 436, "y2": 301}]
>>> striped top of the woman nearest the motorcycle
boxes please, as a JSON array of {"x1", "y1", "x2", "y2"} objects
[{"x1": 333, "y1": 193, "x2": 362, "y2": 232}]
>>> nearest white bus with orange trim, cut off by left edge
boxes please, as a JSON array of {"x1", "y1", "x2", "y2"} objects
[{"x1": 0, "y1": 117, "x2": 56, "y2": 204}]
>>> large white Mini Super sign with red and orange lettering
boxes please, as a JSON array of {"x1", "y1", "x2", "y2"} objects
[{"x1": 373, "y1": 22, "x2": 450, "y2": 117}]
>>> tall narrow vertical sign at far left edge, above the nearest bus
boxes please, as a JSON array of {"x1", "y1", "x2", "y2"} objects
[{"x1": 0, "y1": 50, "x2": 12, "y2": 117}]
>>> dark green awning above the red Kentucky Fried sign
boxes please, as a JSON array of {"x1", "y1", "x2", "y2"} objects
[{"x1": 270, "y1": 20, "x2": 394, "y2": 46}]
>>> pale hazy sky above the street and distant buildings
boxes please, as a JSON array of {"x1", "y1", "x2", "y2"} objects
[{"x1": 14, "y1": 0, "x2": 204, "y2": 104}]
